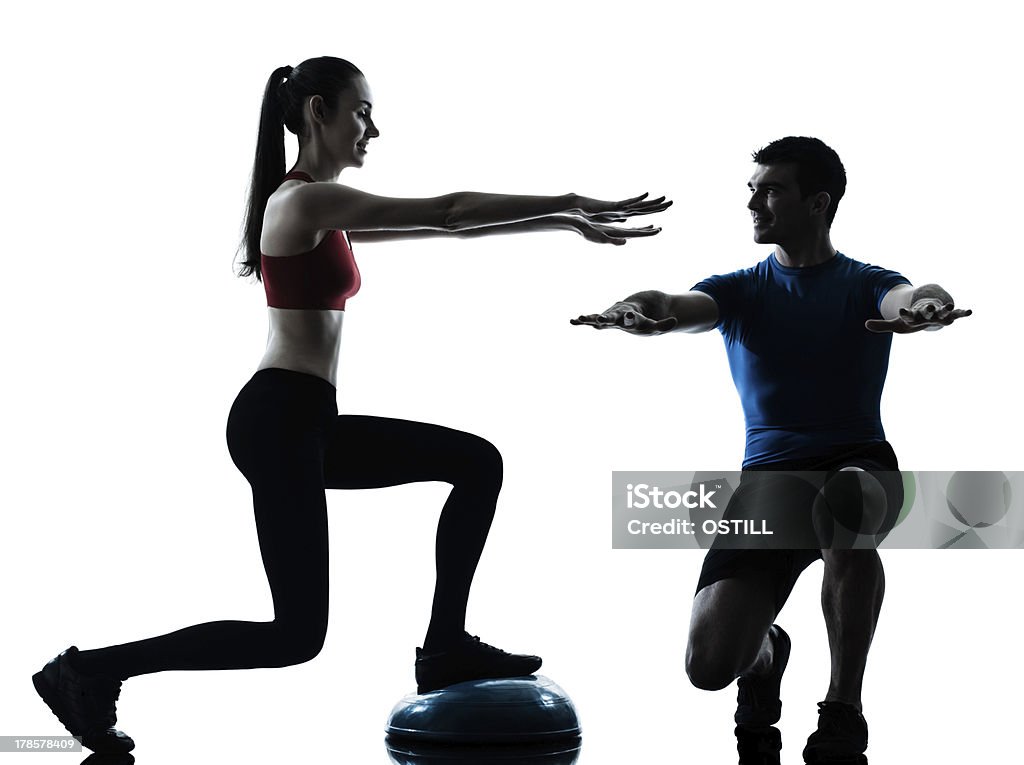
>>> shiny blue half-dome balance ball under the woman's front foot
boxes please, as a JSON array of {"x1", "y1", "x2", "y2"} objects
[{"x1": 387, "y1": 675, "x2": 582, "y2": 753}]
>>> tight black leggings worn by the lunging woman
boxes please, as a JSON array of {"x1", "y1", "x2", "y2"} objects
[{"x1": 79, "y1": 369, "x2": 502, "y2": 679}]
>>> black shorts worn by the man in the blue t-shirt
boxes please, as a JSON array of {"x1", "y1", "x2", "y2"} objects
[{"x1": 694, "y1": 441, "x2": 903, "y2": 613}]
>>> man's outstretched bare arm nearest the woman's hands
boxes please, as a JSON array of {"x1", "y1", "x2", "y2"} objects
[{"x1": 569, "y1": 290, "x2": 718, "y2": 335}]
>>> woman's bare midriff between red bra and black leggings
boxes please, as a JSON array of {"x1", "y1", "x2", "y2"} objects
[{"x1": 257, "y1": 307, "x2": 345, "y2": 387}]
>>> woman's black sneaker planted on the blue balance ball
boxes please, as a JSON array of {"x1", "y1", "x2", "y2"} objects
[{"x1": 416, "y1": 633, "x2": 541, "y2": 693}]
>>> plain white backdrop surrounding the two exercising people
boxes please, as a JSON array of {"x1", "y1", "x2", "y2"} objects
[{"x1": 0, "y1": 2, "x2": 1024, "y2": 765}]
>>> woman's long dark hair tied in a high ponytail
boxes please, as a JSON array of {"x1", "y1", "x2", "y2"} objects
[{"x1": 239, "y1": 55, "x2": 362, "y2": 280}]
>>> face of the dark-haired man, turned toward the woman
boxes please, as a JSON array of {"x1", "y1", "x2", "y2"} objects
[{"x1": 746, "y1": 163, "x2": 827, "y2": 247}]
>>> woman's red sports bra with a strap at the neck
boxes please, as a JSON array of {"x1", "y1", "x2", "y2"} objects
[{"x1": 259, "y1": 170, "x2": 359, "y2": 310}]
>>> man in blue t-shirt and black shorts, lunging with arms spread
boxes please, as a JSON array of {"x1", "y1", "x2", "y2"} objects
[{"x1": 571, "y1": 137, "x2": 971, "y2": 763}]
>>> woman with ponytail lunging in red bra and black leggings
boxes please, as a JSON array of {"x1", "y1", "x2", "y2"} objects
[{"x1": 33, "y1": 57, "x2": 671, "y2": 752}]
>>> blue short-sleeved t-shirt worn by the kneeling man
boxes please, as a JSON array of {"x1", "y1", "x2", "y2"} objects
[{"x1": 693, "y1": 252, "x2": 910, "y2": 467}]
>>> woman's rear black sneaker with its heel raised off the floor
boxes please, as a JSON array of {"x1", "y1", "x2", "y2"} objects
[{"x1": 32, "y1": 645, "x2": 135, "y2": 754}]
